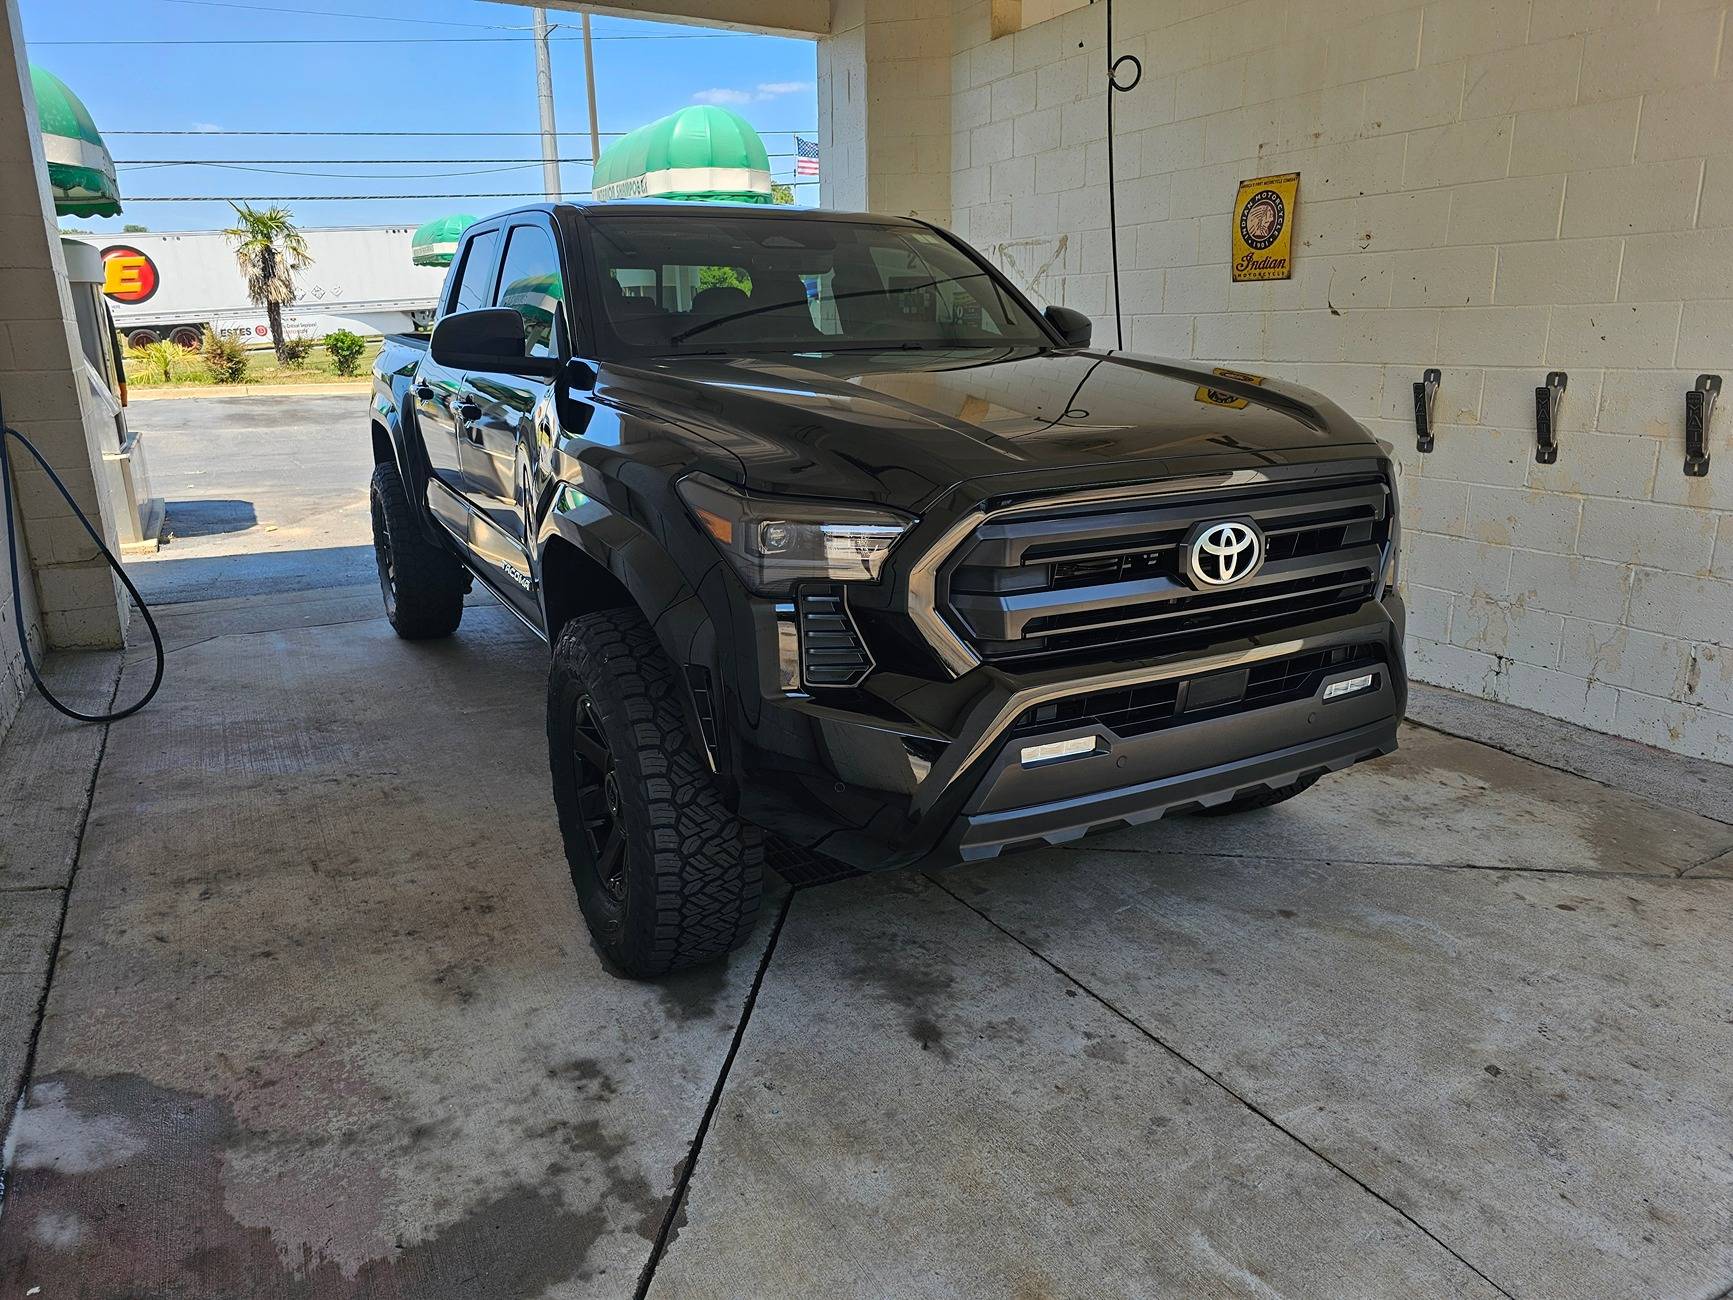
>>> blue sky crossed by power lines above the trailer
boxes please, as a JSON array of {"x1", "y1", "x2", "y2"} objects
[{"x1": 21, "y1": 0, "x2": 818, "y2": 232}]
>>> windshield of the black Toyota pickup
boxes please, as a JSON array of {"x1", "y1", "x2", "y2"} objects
[{"x1": 589, "y1": 211, "x2": 1052, "y2": 355}]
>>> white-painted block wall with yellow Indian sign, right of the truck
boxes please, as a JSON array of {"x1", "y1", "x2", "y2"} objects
[{"x1": 951, "y1": 0, "x2": 1733, "y2": 761}]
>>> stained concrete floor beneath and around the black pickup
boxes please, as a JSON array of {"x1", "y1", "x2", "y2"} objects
[{"x1": 0, "y1": 399, "x2": 1733, "y2": 1300}]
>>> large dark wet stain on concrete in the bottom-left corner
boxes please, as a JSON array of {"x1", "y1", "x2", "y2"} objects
[{"x1": 0, "y1": 1075, "x2": 644, "y2": 1300}]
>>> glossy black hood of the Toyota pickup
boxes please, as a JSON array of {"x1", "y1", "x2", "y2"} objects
[{"x1": 596, "y1": 348, "x2": 1376, "y2": 511}]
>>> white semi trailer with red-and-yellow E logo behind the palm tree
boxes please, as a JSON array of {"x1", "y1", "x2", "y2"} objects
[{"x1": 85, "y1": 225, "x2": 445, "y2": 347}]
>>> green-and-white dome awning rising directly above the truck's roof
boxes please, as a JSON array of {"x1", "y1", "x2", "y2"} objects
[{"x1": 591, "y1": 104, "x2": 775, "y2": 203}]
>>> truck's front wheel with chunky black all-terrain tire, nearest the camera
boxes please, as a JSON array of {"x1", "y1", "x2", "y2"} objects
[{"x1": 548, "y1": 608, "x2": 764, "y2": 979}]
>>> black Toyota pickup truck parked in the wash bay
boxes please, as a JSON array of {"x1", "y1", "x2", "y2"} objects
[{"x1": 371, "y1": 203, "x2": 1407, "y2": 976}]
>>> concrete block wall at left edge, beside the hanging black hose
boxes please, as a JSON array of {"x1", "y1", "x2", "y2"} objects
[{"x1": 0, "y1": 0, "x2": 123, "y2": 733}]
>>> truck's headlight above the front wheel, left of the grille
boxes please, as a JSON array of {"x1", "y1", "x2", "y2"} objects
[{"x1": 678, "y1": 473, "x2": 915, "y2": 595}]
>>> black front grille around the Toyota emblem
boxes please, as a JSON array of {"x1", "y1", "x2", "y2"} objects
[{"x1": 941, "y1": 475, "x2": 1390, "y2": 667}]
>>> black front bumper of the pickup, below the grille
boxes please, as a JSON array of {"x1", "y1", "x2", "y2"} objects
[{"x1": 728, "y1": 593, "x2": 1407, "y2": 870}]
